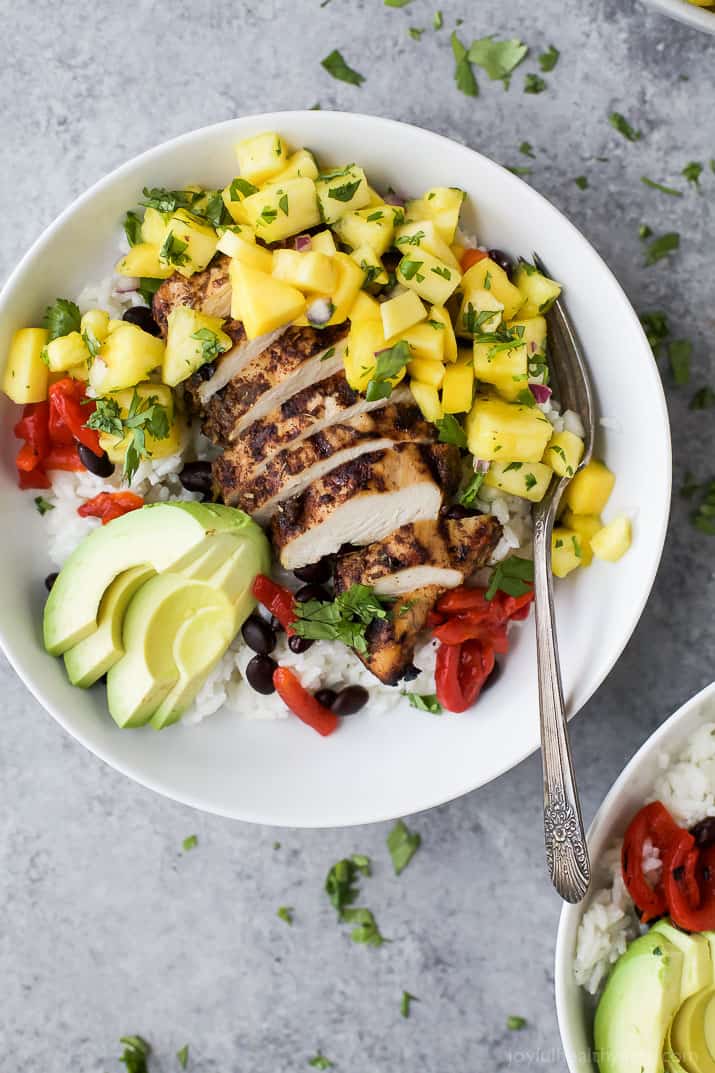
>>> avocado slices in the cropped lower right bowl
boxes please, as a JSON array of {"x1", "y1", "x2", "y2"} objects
[{"x1": 594, "y1": 920, "x2": 715, "y2": 1073}]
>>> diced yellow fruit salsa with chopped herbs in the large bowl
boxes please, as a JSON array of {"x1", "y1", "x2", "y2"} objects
[{"x1": 2, "y1": 131, "x2": 630, "y2": 577}]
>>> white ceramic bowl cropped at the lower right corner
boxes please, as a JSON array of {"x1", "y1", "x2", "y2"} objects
[{"x1": 554, "y1": 682, "x2": 715, "y2": 1073}]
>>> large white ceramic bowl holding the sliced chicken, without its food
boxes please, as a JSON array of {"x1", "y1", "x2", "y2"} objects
[{"x1": 0, "y1": 112, "x2": 671, "y2": 827}]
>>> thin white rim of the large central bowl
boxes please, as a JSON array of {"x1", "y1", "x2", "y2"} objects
[{"x1": 0, "y1": 108, "x2": 672, "y2": 827}]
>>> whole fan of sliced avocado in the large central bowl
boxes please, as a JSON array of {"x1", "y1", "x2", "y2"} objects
[{"x1": 44, "y1": 503, "x2": 271, "y2": 729}]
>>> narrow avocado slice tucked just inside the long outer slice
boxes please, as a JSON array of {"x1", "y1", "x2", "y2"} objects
[{"x1": 64, "y1": 567, "x2": 154, "y2": 689}]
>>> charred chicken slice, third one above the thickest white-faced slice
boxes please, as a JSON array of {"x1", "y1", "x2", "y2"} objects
[{"x1": 198, "y1": 324, "x2": 347, "y2": 444}]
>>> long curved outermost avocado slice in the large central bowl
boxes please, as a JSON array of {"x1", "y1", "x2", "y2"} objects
[{"x1": 44, "y1": 502, "x2": 258, "y2": 656}]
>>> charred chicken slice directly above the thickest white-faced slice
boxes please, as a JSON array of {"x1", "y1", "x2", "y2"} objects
[{"x1": 220, "y1": 403, "x2": 436, "y2": 525}]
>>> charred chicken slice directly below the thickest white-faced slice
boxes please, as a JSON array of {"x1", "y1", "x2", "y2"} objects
[{"x1": 335, "y1": 514, "x2": 501, "y2": 597}]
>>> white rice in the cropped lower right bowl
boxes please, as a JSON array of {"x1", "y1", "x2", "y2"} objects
[{"x1": 573, "y1": 723, "x2": 715, "y2": 995}]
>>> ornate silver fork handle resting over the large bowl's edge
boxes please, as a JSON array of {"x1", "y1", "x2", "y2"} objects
[{"x1": 534, "y1": 506, "x2": 590, "y2": 902}]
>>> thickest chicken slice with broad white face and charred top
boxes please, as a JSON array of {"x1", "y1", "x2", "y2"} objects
[{"x1": 272, "y1": 443, "x2": 459, "y2": 570}]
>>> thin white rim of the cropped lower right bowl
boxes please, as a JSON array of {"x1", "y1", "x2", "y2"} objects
[{"x1": 554, "y1": 680, "x2": 715, "y2": 1073}]
